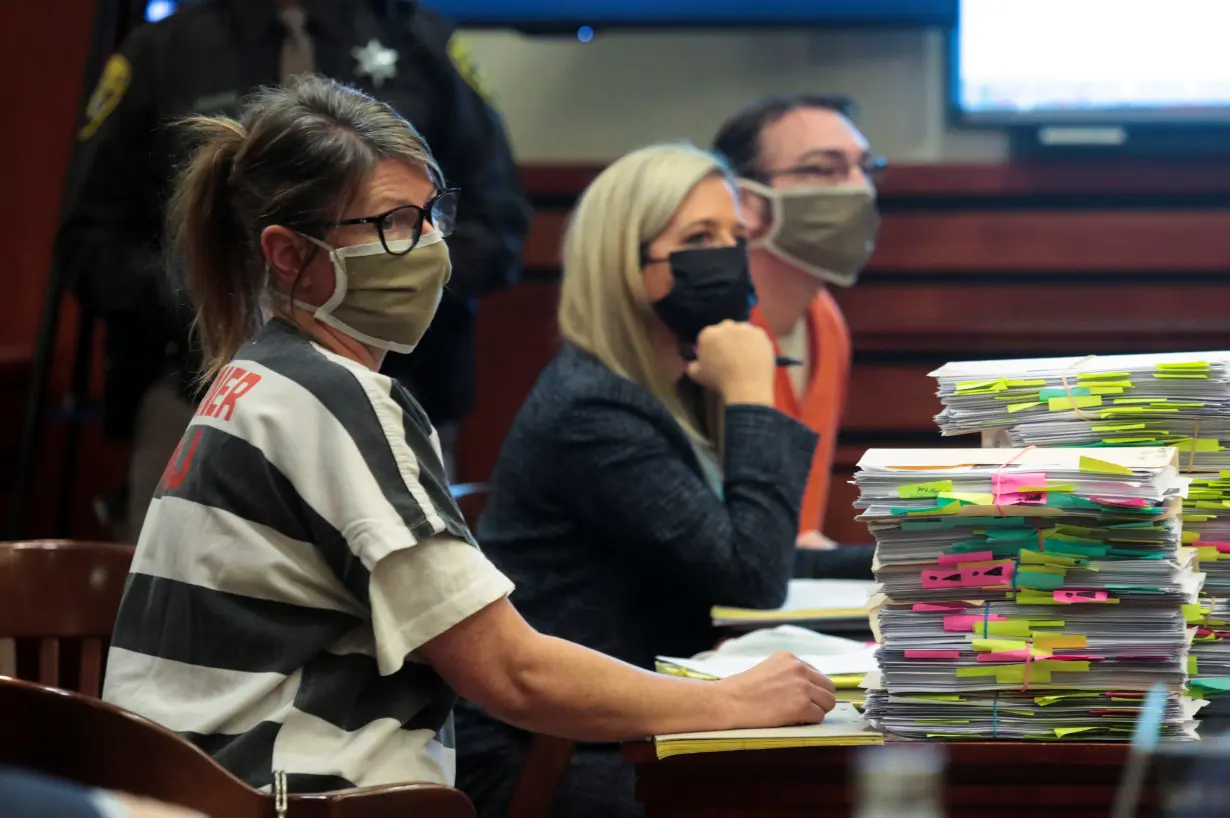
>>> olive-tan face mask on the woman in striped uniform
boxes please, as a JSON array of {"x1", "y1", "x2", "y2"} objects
[{"x1": 295, "y1": 231, "x2": 453, "y2": 353}]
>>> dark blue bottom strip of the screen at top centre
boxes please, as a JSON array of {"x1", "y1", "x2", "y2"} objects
[{"x1": 426, "y1": 0, "x2": 957, "y2": 31}]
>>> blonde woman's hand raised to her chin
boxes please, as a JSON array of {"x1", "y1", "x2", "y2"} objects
[{"x1": 688, "y1": 321, "x2": 776, "y2": 406}]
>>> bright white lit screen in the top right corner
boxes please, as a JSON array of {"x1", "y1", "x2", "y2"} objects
[{"x1": 951, "y1": 0, "x2": 1230, "y2": 127}]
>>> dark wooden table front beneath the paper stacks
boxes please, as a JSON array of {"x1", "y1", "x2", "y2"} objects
[{"x1": 624, "y1": 742, "x2": 1157, "y2": 818}]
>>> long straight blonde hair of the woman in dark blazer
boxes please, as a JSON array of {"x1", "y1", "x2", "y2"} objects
[{"x1": 558, "y1": 144, "x2": 733, "y2": 437}]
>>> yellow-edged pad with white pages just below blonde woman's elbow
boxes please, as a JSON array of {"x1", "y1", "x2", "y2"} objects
[{"x1": 712, "y1": 579, "x2": 876, "y2": 631}]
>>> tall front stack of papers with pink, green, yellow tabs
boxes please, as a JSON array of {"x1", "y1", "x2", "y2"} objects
[{"x1": 855, "y1": 448, "x2": 1203, "y2": 741}]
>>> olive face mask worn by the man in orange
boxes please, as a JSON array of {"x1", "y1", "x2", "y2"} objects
[{"x1": 739, "y1": 180, "x2": 879, "y2": 287}]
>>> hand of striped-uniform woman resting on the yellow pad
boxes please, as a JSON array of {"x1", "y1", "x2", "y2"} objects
[{"x1": 713, "y1": 653, "x2": 836, "y2": 729}]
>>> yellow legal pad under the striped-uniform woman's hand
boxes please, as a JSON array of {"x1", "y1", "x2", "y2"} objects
[{"x1": 653, "y1": 704, "x2": 884, "y2": 759}]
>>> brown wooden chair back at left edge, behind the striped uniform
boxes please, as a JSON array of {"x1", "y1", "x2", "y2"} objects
[{"x1": 0, "y1": 540, "x2": 133, "y2": 696}]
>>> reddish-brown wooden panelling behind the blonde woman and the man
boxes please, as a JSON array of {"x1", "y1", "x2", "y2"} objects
[{"x1": 459, "y1": 161, "x2": 1230, "y2": 542}]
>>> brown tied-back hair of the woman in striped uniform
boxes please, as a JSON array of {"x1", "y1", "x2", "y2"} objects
[{"x1": 166, "y1": 76, "x2": 443, "y2": 383}]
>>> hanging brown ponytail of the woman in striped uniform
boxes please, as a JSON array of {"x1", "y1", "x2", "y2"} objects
[{"x1": 167, "y1": 117, "x2": 264, "y2": 381}]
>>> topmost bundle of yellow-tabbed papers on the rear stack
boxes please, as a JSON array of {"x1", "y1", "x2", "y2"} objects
[{"x1": 931, "y1": 352, "x2": 1230, "y2": 471}]
